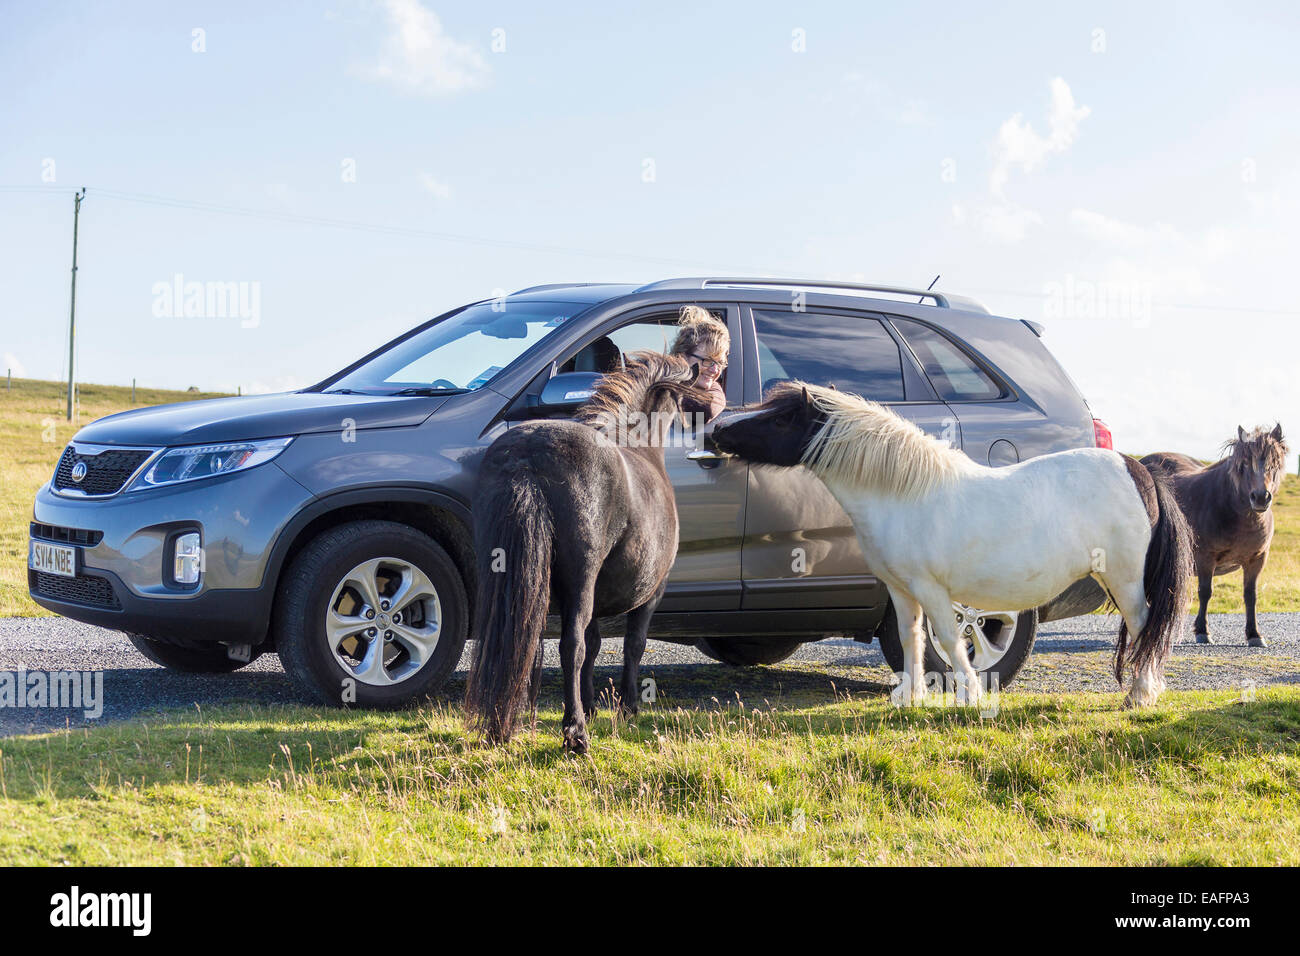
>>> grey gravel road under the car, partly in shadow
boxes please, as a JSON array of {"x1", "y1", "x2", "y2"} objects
[{"x1": 0, "y1": 614, "x2": 1300, "y2": 737}]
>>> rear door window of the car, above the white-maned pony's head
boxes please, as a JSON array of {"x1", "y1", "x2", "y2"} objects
[{"x1": 754, "y1": 308, "x2": 904, "y2": 402}]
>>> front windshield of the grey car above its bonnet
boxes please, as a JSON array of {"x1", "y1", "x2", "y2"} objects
[{"x1": 326, "y1": 299, "x2": 589, "y2": 395}]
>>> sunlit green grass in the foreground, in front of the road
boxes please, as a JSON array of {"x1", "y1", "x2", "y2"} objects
[{"x1": 0, "y1": 687, "x2": 1300, "y2": 866}]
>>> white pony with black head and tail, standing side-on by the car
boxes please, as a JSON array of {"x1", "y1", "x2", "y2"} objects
[{"x1": 712, "y1": 382, "x2": 1191, "y2": 706}]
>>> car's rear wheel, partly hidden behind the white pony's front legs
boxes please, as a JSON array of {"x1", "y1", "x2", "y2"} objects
[{"x1": 876, "y1": 602, "x2": 1039, "y2": 687}]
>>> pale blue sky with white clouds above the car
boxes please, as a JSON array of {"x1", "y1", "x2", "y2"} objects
[{"x1": 0, "y1": 0, "x2": 1300, "y2": 457}]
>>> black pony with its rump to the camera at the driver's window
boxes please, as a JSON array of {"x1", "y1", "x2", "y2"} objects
[{"x1": 465, "y1": 352, "x2": 699, "y2": 753}]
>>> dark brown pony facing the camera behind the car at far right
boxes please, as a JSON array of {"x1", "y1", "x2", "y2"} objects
[{"x1": 1141, "y1": 425, "x2": 1287, "y2": 648}]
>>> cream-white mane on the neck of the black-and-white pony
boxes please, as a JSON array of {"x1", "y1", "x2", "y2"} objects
[{"x1": 781, "y1": 382, "x2": 979, "y2": 499}]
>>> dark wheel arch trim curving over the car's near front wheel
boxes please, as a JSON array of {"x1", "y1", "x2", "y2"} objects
[{"x1": 263, "y1": 485, "x2": 476, "y2": 644}]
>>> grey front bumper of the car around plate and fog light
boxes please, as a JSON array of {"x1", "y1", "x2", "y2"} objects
[{"x1": 27, "y1": 462, "x2": 313, "y2": 644}]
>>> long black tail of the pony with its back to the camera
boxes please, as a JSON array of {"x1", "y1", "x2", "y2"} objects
[{"x1": 465, "y1": 475, "x2": 555, "y2": 744}]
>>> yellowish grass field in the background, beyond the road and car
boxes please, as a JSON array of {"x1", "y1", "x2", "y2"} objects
[{"x1": 0, "y1": 380, "x2": 1300, "y2": 617}]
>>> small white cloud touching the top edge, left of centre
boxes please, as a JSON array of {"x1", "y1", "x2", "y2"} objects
[{"x1": 359, "y1": 0, "x2": 488, "y2": 96}]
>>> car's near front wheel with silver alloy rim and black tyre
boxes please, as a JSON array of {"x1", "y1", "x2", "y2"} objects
[{"x1": 274, "y1": 520, "x2": 469, "y2": 710}]
